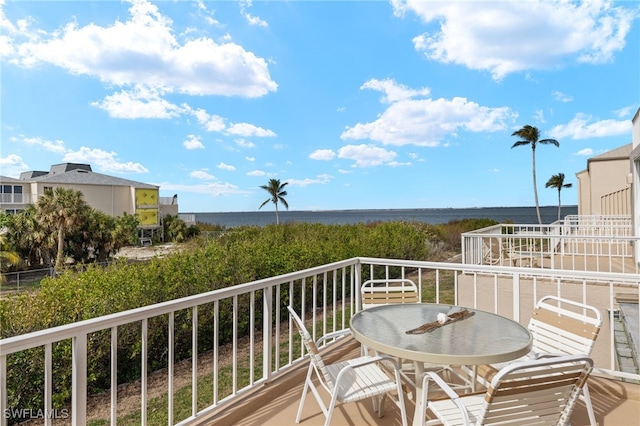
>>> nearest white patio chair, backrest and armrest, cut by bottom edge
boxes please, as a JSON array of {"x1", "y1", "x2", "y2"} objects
[{"x1": 416, "y1": 355, "x2": 593, "y2": 426}]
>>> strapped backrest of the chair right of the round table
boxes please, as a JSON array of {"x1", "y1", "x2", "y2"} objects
[{"x1": 528, "y1": 296, "x2": 602, "y2": 355}]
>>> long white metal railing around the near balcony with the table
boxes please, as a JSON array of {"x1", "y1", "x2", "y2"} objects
[{"x1": 0, "y1": 258, "x2": 640, "y2": 425}]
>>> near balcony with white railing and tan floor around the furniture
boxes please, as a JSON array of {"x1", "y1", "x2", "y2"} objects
[{"x1": 0, "y1": 218, "x2": 640, "y2": 425}]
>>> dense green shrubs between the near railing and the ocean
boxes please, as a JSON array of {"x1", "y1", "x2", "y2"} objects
[{"x1": 0, "y1": 220, "x2": 495, "y2": 418}]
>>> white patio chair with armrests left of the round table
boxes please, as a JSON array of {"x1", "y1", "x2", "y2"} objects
[{"x1": 287, "y1": 306, "x2": 407, "y2": 426}]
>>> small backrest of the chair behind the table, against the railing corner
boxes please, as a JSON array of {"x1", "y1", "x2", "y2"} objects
[{"x1": 360, "y1": 278, "x2": 420, "y2": 309}]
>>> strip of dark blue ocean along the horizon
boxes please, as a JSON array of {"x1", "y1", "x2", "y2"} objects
[{"x1": 185, "y1": 206, "x2": 578, "y2": 228}]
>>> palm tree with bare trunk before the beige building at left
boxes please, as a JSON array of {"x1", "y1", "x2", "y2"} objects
[{"x1": 36, "y1": 187, "x2": 88, "y2": 271}]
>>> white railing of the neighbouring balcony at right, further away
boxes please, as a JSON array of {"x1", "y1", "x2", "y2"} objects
[{"x1": 462, "y1": 216, "x2": 639, "y2": 274}]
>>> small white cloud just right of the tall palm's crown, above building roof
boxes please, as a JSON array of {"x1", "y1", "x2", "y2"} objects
[{"x1": 549, "y1": 114, "x2": 631, "y2": 139}]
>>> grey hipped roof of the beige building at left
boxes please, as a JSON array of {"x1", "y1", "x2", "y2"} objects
[{"x1": 20, "y1": 163, "x2": 160, "y2": 189}]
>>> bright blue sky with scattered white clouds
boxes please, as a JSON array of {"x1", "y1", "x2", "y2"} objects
[{"x1": 0, "y1": 0, "x2": 640, "y2": 212}]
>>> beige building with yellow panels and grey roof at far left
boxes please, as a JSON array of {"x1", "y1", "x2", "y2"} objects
[{"x1": 0, "y1": 163, "x2": 178, "y2": 237}]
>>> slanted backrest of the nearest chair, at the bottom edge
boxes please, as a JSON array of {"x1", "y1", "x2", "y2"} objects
[{"x1": 477, "y1": 355, "x2": 593, "y2": 425}]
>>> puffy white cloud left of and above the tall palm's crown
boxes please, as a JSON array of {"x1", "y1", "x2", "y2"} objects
[{"x1": 340, "y1": 80, "x2": 516, "y2": 147}]
